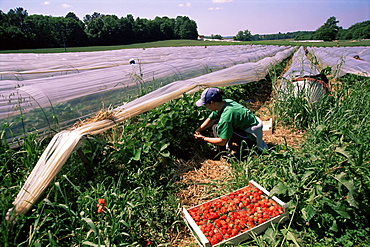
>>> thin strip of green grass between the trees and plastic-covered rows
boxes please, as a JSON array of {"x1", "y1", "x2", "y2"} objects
[{"x1": 0, "y1": 40, "x2": 370, "y2": 54}]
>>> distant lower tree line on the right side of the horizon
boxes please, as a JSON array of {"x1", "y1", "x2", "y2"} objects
[{"x1": 234, "y1": 16, "x2": 370, "y2": 41}]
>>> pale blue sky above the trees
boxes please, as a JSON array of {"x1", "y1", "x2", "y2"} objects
[{"x1": 0, "y1": 0, "x2": 370, "y2": 36}]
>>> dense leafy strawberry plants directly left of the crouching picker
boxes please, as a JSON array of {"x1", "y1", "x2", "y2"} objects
[{"x1": 104, "y1": 91, "x2": 207, "y2": 164}]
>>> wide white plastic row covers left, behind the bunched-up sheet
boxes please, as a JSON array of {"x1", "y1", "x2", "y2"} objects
[{"x1": 0, "y1": 46, "x2": 287, "y2": 144}]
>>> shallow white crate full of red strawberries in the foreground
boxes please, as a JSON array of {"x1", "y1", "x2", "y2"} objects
[{"x1": 183, "y1": 180, "x2": 289, "y2": 247}]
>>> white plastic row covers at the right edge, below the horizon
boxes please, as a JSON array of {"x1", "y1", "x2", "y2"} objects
[{"x1": 308, "y1": 47, "x2": 370, "y2": 77}]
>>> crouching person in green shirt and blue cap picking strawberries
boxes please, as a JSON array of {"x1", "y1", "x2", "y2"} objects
[{"x1": 194, "y1": 88, "x2": 268, "y2": 153}]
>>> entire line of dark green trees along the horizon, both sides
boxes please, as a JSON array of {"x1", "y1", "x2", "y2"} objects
[{"x1": 0, "y1": 7, "x2": 370, "y2": 50}]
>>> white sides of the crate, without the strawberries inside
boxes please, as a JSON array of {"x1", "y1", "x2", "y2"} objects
[{"x1": 183, "y1": 180, "x2": 289, "y2": 247}]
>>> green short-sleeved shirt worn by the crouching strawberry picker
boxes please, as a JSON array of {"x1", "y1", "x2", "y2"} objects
[{"x1": 209, "y1": 99, "x2": 258, "y2": 139}]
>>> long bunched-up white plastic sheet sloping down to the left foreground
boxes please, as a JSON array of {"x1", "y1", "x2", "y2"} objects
[{"x1": 6, "y1": 45, "x2": 294, "y2": 222}]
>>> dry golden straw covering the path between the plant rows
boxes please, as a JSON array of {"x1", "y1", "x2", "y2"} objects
[{"x1": 171, "y1": 78, "x2": 304, "y2": 247}]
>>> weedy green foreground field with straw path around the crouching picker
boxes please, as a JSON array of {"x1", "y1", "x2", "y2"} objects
[{"x1": 0, "y1": 42, "x2": 370, "y2": 246}]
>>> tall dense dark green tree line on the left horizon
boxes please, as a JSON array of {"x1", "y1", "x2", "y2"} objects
[{"x1": 0, "y1": 7, "x2": 198, "y2": 50}]
